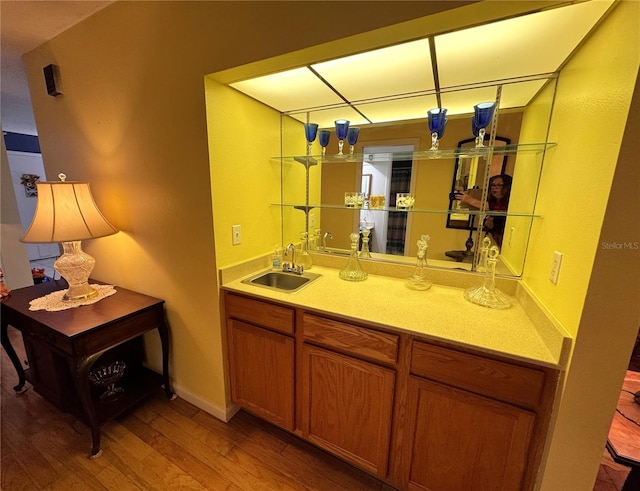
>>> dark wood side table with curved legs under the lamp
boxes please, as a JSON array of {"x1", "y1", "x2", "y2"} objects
[{"x1": 0, "y1": 280, "x2": 175, "y2": 458}]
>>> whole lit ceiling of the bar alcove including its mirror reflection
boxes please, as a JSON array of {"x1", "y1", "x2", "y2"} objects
[{"x1": 231, "y1": 0, "x2": 614, "y2": 127}]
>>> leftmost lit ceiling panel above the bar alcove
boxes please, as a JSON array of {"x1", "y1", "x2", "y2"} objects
[{"x1": 230, "y1": 67, "x2": 343, "y2": 112}]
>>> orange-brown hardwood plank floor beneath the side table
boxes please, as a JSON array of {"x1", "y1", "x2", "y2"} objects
[{"x1": 0, "y1": 328, "x2": 628, "y2": 491}]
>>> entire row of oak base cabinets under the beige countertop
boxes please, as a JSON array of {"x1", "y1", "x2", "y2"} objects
[{"x1": 225, "y1": 292, "x2": 558, "y2": 491}]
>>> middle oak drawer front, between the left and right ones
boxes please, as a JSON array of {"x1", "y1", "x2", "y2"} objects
[{"x1": 302, "y1": 313, "x2": 398, "y2": 363}]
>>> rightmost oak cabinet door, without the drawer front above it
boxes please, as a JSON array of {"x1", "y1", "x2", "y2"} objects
[{"x1": 407, "y1": 377, "x2": 535, "y2": 491}]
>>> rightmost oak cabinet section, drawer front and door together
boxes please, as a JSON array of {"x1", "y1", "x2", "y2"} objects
[{"x1": 390, "y1": 341, "x2": 546, "y2": 491}]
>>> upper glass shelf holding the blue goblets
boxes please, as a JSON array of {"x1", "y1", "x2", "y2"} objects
[{"x1": 271, "y1": 142, "x2": 556, "y2": 167}]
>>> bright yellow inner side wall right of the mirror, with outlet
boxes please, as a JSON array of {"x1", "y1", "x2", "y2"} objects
[{"x1": 524, "y1": 2, "x2": 638, "y2": 336}]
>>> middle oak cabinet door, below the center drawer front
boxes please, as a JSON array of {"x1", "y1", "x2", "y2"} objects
[{"x1": 301, "y1": 344, "x2": 395, "y2": 477}]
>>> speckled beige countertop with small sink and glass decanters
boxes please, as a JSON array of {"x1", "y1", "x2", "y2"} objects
[{"x1": 221, "y1": 258, "x2": 571, "y2": 368}]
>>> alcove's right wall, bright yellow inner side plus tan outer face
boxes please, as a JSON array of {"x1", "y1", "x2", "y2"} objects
[{"x1": 523, "y1": 1, "x2": 640, "y2": 491}]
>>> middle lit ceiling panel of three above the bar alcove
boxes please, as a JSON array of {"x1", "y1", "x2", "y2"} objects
[{"x1": 311, "y1": 39, "x2": 435, "y2": 102}]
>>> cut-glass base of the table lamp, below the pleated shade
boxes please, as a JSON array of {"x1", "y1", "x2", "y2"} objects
[{"x1": 53, "y1": 240, "x2": 98, "y2": 302}]
